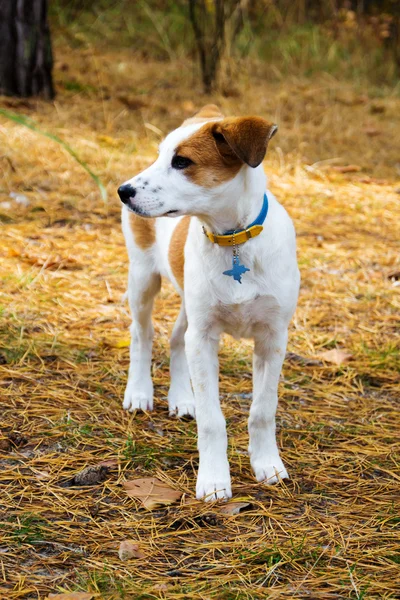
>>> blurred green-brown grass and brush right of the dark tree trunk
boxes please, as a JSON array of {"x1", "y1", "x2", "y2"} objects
[{"x1": 51, "y1": 0, "x2": 400, "y2": 93}]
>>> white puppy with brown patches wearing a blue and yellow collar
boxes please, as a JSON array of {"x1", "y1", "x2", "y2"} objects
[{"x1": 118, "y1": 105, "x2": 300, "y2": 500}]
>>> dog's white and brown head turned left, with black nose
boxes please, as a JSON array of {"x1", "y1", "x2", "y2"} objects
[{"x1": 118, "y1": 105, "x2": 278, "y2": 217}]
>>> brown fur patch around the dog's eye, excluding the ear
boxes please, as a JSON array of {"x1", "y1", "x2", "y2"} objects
[{"x1": 175, "y1": 123, "x2": 243, "y2": 188}]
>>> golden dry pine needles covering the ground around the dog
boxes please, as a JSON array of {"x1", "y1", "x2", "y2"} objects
[{"x1": 0, "y1": 43, "x2": 400, "y2": 600}]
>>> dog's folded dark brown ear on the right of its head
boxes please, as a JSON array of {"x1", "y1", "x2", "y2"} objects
[{"x1": 211, "y1": 117, "x2": 278, "y2": 168}]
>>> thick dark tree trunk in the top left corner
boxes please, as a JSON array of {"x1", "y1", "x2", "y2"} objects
[{"x1": 0, "y1": 0, "x2": 54, "y2": 99}]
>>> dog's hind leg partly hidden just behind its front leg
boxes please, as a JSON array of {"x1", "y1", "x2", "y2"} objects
[{"x1": 168, "y1": 299, "x2": 195, "y2": 417}]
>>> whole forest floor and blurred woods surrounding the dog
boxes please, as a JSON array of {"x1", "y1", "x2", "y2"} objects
[{"x1": 0, "y1": 0, "x2": 400, "y2": 600}]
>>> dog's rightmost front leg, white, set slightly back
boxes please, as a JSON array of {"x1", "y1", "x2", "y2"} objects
[{"x1": 248, "y1": 329, "x2": 288, "y2": 483}]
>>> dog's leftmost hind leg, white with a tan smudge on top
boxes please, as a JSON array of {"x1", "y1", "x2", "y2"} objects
[{"x1": 123, "y1": 260, "x2": 161, "y2": 411}]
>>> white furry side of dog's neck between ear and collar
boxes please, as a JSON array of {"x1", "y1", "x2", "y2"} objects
[{"x1": 198, "y1": 165, "x2": 267, "y2": 234}]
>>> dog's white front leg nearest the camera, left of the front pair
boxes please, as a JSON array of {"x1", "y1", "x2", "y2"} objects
[{"x1": 185, "y1": 324, "x2": 232, "y2": 501}]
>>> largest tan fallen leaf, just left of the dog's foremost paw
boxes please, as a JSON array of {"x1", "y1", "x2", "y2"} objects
[{"x1": 124, "y1": 477, "x2": 182, "y2": 510}]
